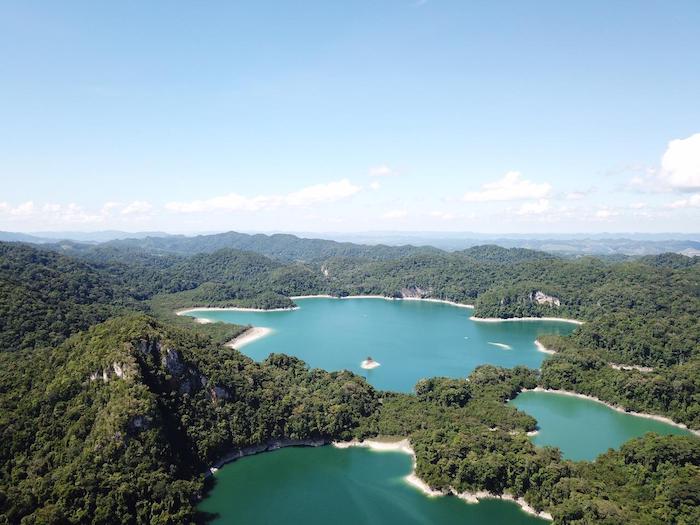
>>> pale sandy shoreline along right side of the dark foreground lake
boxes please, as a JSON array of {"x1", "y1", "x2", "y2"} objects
[{"x1": 333, "y1": 439, "x2": 552, "y2": 521}]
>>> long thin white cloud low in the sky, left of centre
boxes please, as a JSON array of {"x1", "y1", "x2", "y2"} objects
[{"x1": 165, "y1": 179, "x2": 361, "y2": 213}]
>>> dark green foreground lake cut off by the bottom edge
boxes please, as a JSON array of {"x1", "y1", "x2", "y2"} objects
[{"x1": 199, "y1": 446, "x2": 547, "y2": 525}]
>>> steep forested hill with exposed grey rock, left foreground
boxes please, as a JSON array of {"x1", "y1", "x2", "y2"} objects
[{"x1": 0, "y1": 316, "x2": 377, "y2": 523}]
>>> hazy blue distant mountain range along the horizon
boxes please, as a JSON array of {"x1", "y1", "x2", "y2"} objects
[{"x1": 0, "y1": 230, "x2": 700, "y2": 260}]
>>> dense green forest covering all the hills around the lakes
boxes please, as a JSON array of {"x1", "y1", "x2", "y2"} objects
[{"x1": 0, "y1": 234, "x2": 700, "y2": 524}]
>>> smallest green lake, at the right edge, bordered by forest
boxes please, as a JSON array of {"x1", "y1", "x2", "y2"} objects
[{"x1": 512, "y1": 392, "x2": 691, "y2": 460}]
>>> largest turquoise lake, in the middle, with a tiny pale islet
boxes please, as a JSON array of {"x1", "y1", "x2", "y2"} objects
[{"x1": 187, "y1": 298, "x2": 575, "y2": 392}]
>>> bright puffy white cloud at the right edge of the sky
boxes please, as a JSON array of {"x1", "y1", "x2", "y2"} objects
[{"x1": 660, "y1": 133, "x2": 700, "y2": 191}]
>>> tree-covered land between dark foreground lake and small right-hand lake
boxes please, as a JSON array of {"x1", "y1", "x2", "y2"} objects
[{"x1": 368, "y1": 366, "x2": 700, "y2": 525}]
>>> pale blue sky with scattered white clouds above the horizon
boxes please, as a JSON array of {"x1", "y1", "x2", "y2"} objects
[{"x1": 0, "y1": 0, "x2": 700, "y2": 233}]
